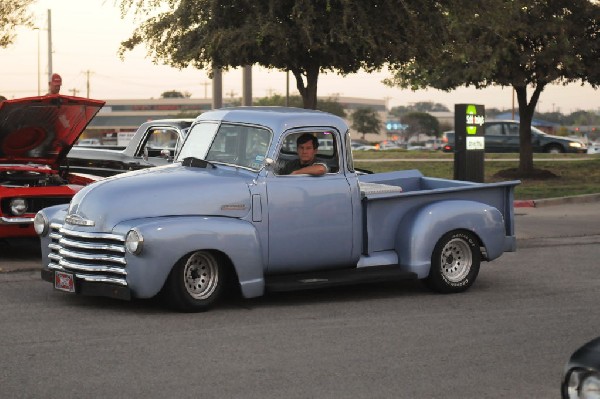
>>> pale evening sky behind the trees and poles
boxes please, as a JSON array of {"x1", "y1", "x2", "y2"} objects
[{"x1": 0, "y1": 0, "x2": 600, "y2": 114}]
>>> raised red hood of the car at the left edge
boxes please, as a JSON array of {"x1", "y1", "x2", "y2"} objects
[{"x1": 0, "y1": 94, "x2": 104, "y2": 168}]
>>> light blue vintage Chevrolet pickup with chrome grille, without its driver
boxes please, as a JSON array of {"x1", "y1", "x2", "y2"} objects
[{"x1": 35, "y1": 107, "x2": 519, "y2": 311}]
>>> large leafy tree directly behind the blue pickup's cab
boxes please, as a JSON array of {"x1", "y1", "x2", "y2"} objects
[{"x1": 119, "y1": 0, "x2": 426, "y2": 109}]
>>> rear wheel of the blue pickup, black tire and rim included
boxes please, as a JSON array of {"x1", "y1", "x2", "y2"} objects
[{"x1": 425, "y1": 230, "x2": 481, "y2": 294}]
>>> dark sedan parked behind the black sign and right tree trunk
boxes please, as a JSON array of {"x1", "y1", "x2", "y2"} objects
[{"x1": 442, "y1": 121, "x2": 587, "y2": 153}]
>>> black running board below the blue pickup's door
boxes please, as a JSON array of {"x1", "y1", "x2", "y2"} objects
[{"x1": 265, "y1": 265, "x2": 417, "y2": 292}]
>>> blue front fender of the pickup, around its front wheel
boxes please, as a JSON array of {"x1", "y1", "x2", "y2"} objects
[{"x1": 113, "y1": 216, "x2": 264, "y2": 298}]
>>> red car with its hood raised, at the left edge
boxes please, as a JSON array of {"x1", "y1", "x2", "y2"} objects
[{"x1": 0, "y1": 94, "x2": 104, "y2": 239}]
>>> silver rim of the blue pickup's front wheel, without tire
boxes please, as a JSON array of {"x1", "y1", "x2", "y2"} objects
[{"x1": 183, "y1": 252, "x2": 219, "y2": 300}]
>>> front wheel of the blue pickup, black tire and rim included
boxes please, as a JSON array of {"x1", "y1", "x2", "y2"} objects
[{"x1": 164, "y1": 251, "x2": 226, "y2": 312}]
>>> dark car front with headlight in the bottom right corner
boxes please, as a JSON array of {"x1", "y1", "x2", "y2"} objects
[{"x1": 560, "y1": 337, "x2": 600, "y2": 399}]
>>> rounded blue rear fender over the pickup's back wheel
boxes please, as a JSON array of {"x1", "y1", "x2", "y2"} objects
[{"x1": 395, "y1": 200, "x2": 505, "y2": 278}]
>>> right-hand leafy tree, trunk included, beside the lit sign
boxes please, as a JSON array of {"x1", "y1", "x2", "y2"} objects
[{"x1": 387, "y1": 0, "x2": 600, "y2": 176}]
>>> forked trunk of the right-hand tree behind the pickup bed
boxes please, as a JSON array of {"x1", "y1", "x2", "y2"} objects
[{"x1": 514, "y1": 84, "x2": 545, "y2": 176}]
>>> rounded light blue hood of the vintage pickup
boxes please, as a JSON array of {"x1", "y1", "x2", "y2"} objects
[{"x1": 68, "y1": 164, "x2": 252, "y2": 232}]
